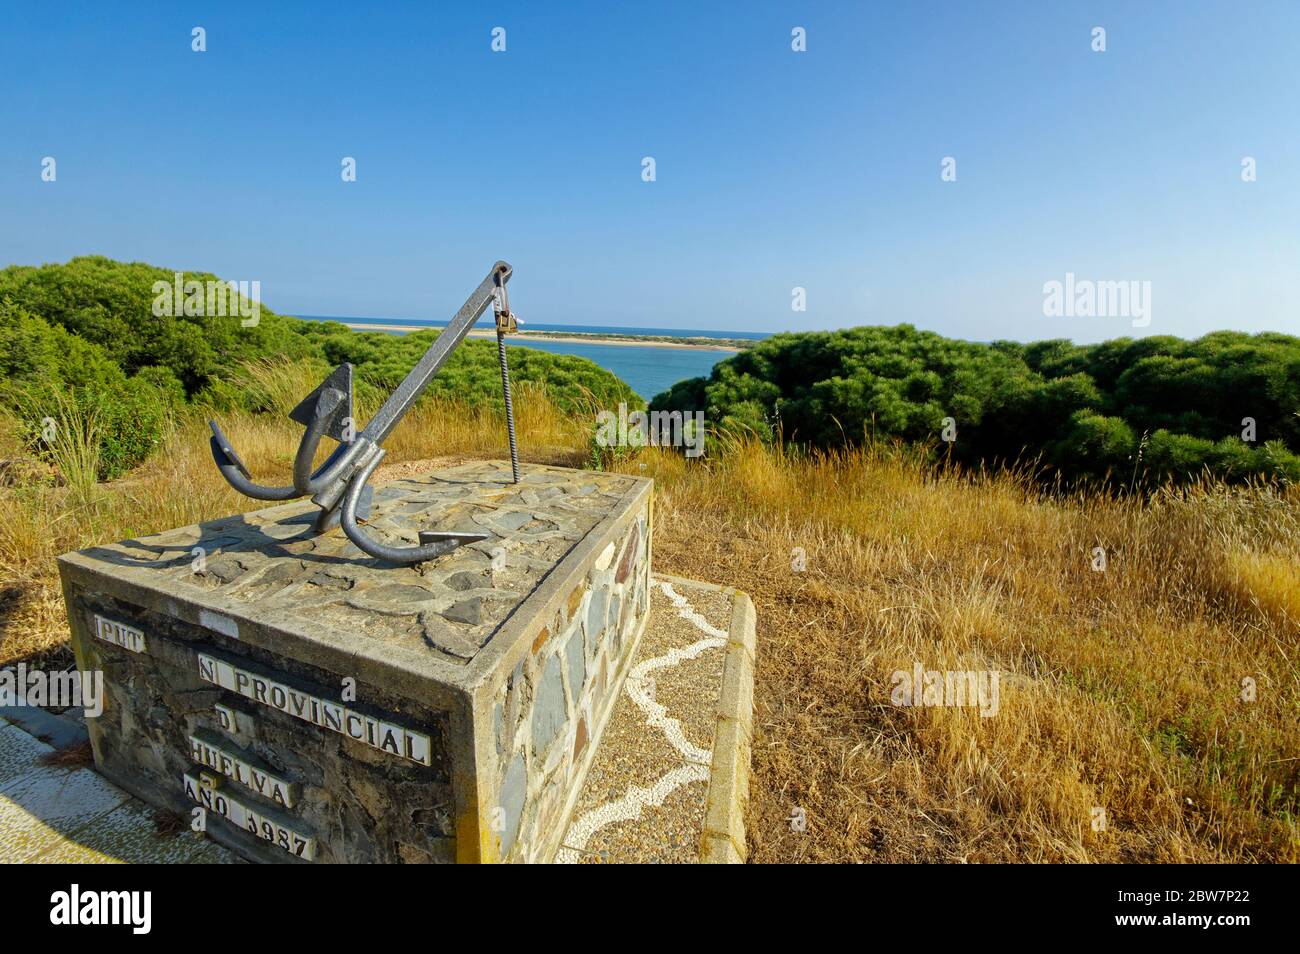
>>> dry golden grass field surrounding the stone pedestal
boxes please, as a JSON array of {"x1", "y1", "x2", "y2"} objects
[{"x1": 0, "y1": 380, "x2": 1300, "y2": 862}]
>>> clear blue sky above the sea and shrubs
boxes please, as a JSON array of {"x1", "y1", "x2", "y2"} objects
[{"x1": 0, "y1": 0, "x2": 1300, "y2": 341}]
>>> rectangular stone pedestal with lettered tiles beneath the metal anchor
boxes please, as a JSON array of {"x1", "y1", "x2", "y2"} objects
[{"x1": 59, "y1": 461, "x2": 651, "y2": 862}]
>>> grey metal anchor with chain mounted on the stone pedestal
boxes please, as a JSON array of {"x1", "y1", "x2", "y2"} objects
[{"x1": 208, "y1": 261, "x2": 519, "y2": 564}]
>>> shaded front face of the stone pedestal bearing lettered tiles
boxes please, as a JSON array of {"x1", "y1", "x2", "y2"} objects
[{"x1": 68, "y1": 586, "x2": 456, "y2": 863}]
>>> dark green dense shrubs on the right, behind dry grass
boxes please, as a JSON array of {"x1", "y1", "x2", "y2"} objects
[{"x1": 651, "y1": 325, "x2": 1300, "y2": 483}]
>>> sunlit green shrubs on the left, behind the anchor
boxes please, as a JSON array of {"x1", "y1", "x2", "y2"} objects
[{"x1": 0, "y1": 256, "x2": 644, "y2": 478}]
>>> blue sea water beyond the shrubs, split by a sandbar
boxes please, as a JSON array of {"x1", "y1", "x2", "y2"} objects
[{"x1": 299, "y1": 315, "x2": 768, "y2": 400}]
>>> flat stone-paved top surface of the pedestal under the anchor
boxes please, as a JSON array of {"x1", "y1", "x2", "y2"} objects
[{"x1": 59, "y1": 461, "x2": 651, "y2": 684}]
